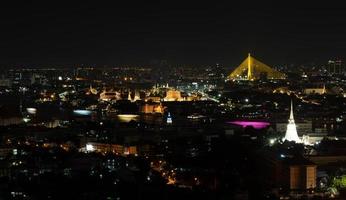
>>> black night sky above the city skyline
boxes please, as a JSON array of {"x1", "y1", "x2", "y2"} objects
[{"x1": 0, "y1": 1, "x2": 346, "y2": 66}]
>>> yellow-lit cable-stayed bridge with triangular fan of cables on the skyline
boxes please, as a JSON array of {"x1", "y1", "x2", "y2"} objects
[{"x1": 228, "y1": 54, "x2": 286, "y2": 80}]
